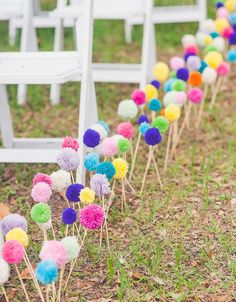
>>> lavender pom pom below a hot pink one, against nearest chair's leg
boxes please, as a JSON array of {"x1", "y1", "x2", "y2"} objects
[{"x1": 57, "y1": 148, "x2": 79, "y2": 171}]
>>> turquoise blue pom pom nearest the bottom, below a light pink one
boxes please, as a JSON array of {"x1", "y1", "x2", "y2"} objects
[{"x1": 35, "y1": 260, "x2": 58, "y2": 285}]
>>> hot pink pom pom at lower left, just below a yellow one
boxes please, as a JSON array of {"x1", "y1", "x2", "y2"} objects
[{"x1": 2, "y1": 240, "x2": 25, "y2": 264}]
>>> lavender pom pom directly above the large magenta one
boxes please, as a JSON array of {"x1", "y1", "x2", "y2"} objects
[{"x1": 90, "y1": 174, "x2": 111, "y2": 198}]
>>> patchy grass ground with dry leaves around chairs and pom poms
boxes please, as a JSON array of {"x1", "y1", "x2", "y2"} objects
[{"x1": 0, "y1": 0, "x2": 236, "y2": 302}]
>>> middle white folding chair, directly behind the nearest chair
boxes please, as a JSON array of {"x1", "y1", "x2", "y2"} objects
[{"x1": 50, "y1": 0, "x2": 156, "y2": 104}]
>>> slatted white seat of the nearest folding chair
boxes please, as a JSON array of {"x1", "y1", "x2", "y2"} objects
[{"x1": 0, "y1": 51, "x2": 81, "y2": 84}]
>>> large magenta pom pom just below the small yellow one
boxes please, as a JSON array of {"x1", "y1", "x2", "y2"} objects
[{"x1": 79, "y1": 204, "x2": 104, "y2": 230}]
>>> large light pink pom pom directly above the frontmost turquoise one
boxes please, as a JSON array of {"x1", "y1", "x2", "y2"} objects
[{"x1": 39, "y1": 240, "x2": 67, "y2": 267}]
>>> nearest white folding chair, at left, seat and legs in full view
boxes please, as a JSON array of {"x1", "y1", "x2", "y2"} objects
[{"x1": 0, "y1": 0, "x2": 98, "y2": 181}]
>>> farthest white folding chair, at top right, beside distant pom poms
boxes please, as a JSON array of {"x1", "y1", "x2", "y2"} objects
[{"x1": 125, "y1": 0, "x2": 207, "y2": 43}]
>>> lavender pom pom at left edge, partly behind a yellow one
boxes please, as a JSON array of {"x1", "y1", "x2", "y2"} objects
[{"x1": 1, "y1": 214, "x2": 28, "y2": 236}]
